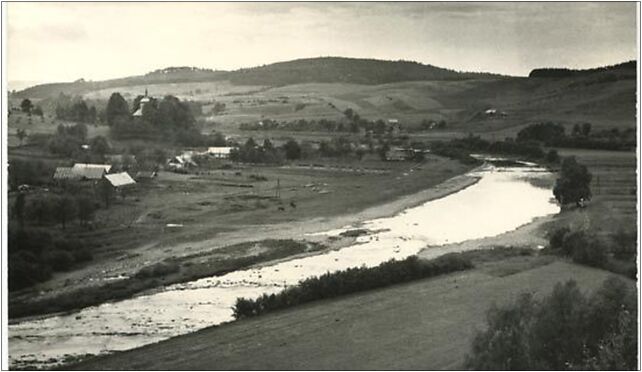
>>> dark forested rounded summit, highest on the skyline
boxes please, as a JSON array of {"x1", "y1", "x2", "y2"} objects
[{"x1": 222, "y1": 57, "x2": 498, "y2": 86}]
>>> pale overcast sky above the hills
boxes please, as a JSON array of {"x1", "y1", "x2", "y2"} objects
[{"x1": 3, "y1": 3, "x2": 637, "y2": 87}]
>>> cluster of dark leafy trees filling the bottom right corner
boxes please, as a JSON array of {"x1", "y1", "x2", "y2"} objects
[{"x1": 465, "y1": 277, "x2": 638, "y2": 371}]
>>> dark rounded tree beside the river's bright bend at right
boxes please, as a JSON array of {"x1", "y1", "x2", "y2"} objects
[{"x1": 553, "y1": 156, "x2": 592, "y2": 205}]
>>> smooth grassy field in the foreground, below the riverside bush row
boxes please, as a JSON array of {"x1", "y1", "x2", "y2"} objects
[{"x1": 74, "y1": 256, "x2": 634, "y2": 370}]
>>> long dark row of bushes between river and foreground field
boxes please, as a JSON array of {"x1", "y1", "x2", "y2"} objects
[{"x1": 234, "y1": 254, "x2": 473, "y2": 319}]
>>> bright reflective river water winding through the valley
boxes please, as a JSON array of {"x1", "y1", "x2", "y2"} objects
[{"x1": 9, "y1": 165, "x2": 559, "y2": 368}]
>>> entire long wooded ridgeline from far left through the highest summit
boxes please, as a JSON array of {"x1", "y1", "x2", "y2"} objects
[{"x1": 12, "y1": 57, "x2": 499, "y2": 98}]
